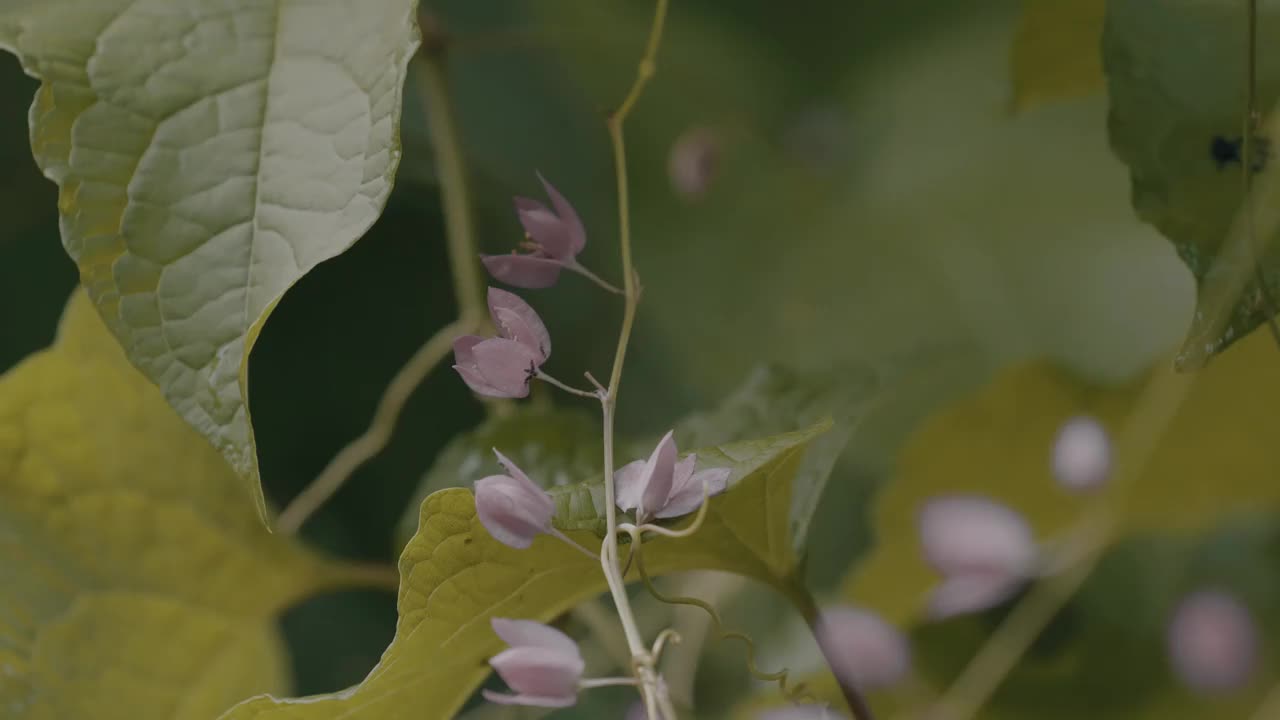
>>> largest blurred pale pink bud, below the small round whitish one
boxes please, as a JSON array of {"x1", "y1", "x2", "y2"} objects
[{"x1": 919, "y1": 496, "x2": 1039, "y2": 619}]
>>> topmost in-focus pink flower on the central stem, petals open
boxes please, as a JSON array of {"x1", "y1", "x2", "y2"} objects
[{"x1": 480, "y1": 174, "x2": 586, "y2": 288}]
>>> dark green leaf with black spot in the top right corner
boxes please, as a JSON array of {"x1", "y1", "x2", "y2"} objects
[{"x1": 1103, "y1": 0, "x2": 1280, "y2": 368}]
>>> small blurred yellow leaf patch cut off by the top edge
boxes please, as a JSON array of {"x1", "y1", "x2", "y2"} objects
[{"x1": 1009, "y1": 0, "x2": 1107, "y2": 113}]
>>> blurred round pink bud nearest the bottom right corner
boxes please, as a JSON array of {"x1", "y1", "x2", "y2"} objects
[{"x1": 1169, "y1": 589, "x2": 1258, "y2": 694}]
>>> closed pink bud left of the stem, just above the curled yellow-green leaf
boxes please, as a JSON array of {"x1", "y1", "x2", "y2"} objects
[{"x1": 475, "y1": 450, "x2": 556, "y2": 550}]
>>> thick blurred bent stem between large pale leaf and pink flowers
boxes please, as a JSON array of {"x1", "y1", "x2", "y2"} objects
[{"x1": 275, "y1": 23, "x2": 485, "y2": 534}]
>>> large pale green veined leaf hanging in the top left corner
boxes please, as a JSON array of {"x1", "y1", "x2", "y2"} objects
[{"x1": 0, "y1": 0, "x2": 417, "y2": 519}]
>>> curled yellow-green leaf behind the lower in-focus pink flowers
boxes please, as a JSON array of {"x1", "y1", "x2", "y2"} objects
[{"x1": 224, "y1": 423, "x2": 829, "y2": 720}]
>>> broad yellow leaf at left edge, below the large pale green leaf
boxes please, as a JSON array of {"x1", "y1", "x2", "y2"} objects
[{"x1": 0, "y1": 292, "x2": 360, "y2": 720}]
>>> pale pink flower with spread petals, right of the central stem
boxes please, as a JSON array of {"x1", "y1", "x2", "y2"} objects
[{"x1": 613, "y1": 432, "x2": 730, "y2": 523}]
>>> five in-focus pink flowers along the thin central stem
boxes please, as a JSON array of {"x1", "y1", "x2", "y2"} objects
[{"x1": 453, "y1": 176, "x2": 730, "y2": 707}]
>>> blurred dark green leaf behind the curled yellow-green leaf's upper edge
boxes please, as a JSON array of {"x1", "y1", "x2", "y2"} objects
[{"x1": 398, "y1": 405, "x2": 603, "y2": 547}]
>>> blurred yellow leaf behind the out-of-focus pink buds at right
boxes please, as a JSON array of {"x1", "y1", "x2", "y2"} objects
[{"x1": 845, "y1": 333, "x2": 1280, "y2": 626}]
